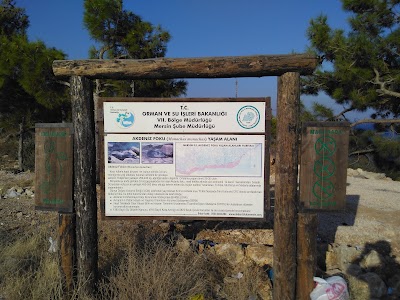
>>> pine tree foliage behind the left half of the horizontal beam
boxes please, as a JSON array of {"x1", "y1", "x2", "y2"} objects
[{"x1": 83, "y1": 0, "x2": 187, "y2": 97}]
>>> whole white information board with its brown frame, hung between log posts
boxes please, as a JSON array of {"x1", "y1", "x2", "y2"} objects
[{"x1": 98, "y1": 98, "x2": 270, "y2": 220}]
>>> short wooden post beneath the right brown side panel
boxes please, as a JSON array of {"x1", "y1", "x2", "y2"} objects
[{"x1": 296, "y1": 213, "x2": 318, "y2": 300}]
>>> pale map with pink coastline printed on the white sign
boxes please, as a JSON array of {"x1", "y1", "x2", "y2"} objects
[{"x1": 175, "y1": 143, "x2": 263, "y2": 177}]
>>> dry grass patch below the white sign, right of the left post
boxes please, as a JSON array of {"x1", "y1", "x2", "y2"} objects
[{"x1": 98, "y1": 222, "x2": 230, "y2": 300}]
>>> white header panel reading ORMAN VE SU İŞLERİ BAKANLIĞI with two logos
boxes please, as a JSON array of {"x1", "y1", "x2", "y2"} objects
[{"x1": 104, "y1": 102, "x2": 265, "y2": 133}]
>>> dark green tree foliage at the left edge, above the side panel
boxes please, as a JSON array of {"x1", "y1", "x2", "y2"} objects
[{"x1": 0, "y1": 0, "x2": 69, "y2": 128}]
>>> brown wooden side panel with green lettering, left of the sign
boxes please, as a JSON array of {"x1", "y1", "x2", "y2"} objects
[{"x1": 35, "y1": 123, "x2": 73, "y2": 212}]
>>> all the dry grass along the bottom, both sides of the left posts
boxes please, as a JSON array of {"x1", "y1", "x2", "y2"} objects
[{"x1": 0, "y1": 217, "x2": 272, "y2": 300}]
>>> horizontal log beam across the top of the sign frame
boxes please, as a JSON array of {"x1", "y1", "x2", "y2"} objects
[{"x1": 53, "y1": 54, "x2": 318, "y2": 79}]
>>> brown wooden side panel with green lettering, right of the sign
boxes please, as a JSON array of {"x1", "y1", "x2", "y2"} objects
[{"x1": 300, "y1": 122, "x2": 350, "y2": 210}]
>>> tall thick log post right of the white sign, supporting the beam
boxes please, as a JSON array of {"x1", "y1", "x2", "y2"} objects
[{"x1": 273, "y1": 72, "x2": 300, "y2": 300}]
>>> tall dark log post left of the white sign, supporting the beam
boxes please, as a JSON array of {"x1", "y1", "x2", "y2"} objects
[{"x1": 71, "y1": 76, "x2": 98, "y2": 294}]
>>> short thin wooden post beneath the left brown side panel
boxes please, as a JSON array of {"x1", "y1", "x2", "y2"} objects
[{"x1": 58, "y1": 213, "x2": 76, "y2": 299}]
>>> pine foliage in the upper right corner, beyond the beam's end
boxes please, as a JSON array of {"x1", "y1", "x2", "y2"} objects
[{"x1": 303, "y1": 0, "x2": 400, "y2": 117}]
